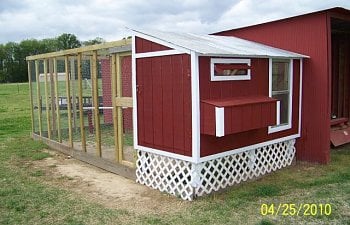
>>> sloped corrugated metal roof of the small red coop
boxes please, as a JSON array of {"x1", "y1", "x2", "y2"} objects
[{"x1": 133, "y1": 30, "x2": 309, "y2": 58}]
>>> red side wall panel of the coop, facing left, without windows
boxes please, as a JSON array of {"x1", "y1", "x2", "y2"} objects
[{"x1": 136, "y1": 54, "x2": 192, "y2": 156}]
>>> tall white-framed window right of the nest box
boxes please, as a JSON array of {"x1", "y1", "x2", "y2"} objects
[{"x1": 269, "y1": 59, "x2": 293, "y2": 133}]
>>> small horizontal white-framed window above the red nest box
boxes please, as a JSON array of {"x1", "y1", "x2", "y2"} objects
[{"x1": 210, "y1": 58, "x2": 250, "y2": 81}]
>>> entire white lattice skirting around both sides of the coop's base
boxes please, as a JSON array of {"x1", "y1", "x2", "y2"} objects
[{"x1": 136, "y1": 139, "x2": 295, "y2": 200}]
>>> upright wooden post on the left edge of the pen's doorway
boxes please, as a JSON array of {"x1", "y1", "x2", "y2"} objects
[{"x1": 111, "y1": 54, "x2": 119, "y2": 162}]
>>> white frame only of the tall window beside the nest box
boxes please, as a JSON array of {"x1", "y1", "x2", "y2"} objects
[{"x1": 268, "y1": 58, "x2": 293, "y2": 134}]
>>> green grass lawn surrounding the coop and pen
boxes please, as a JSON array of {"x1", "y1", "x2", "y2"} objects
[{"x1": 0, "y1": 84, "x2": 350, "y2": 225}]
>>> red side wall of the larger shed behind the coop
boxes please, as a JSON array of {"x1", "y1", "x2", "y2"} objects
[{"x1": 217, "y1": 12, "x2": 330, "y2": 163}]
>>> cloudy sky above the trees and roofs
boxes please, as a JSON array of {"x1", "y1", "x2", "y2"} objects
[{"x1": 0, "y1": 0, "x2": 350, "y2": 43}]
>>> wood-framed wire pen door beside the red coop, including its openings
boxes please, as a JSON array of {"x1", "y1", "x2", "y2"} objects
[{"x1": 111, "y1": 53, "x2": 135, "y2": 167}]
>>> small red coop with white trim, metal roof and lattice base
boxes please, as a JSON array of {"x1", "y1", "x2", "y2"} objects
[{"x1": 132, "y1": 31, "x2": 307, "y2": 199}]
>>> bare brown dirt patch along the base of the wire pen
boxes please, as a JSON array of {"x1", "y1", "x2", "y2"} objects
[{"x1": 34, "y1": 151, "x2": 189, "y2": 214}]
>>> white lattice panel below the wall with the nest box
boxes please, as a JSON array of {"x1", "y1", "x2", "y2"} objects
[{"x1": 195, "y1": 139, "x2": 295, "y2": 196}]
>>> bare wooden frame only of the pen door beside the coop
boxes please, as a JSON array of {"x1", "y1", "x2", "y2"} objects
[{"x1": 111, "y1": 53, "x2": 135, "y2": 168}]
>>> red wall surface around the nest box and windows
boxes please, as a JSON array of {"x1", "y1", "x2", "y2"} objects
[{"x1": 199, "y1": 57, "x2": 300, "y2": 157}]
